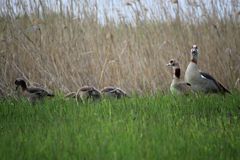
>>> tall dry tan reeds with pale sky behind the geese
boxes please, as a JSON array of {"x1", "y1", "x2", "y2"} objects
[{"x1": 0, "y1": 0, "x2": 240, "y2": 94}]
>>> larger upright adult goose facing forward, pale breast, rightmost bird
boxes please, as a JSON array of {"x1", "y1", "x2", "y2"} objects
[{"x1": 185, "y1": 45, "x2": 230, "y2": 93}]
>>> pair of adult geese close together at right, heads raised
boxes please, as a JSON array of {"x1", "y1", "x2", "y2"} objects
[{"x1": 167, "y1": 45, "x2": 230, "y2": 94}]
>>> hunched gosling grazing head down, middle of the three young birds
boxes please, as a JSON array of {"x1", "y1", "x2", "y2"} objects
[{"x1": 65, "y1": 86, "x2": 101, "y2": 102}]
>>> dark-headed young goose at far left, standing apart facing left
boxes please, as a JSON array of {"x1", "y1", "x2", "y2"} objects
[{"x1": 15, "y1": 78, "x2": 54, "y2": 104}]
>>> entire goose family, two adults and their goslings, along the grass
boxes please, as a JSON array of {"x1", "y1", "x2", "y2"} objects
[{"x1": 15, "y1": 45, "x2": 230, "y2": 104}]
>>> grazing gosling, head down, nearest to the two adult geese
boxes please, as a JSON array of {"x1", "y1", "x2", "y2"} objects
[{"x1": 101, "y1": 86, "x2": 129, "y2": 99}]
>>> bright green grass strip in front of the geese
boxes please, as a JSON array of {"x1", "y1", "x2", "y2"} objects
[{"x1": 0, "y1": 92, "x2": 240, "y2": 160}]
